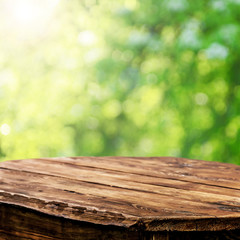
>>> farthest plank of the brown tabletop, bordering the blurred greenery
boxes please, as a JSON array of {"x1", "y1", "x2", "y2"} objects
[{"x1": 6, "y1": 157, "x2": 240, "y2": 189}]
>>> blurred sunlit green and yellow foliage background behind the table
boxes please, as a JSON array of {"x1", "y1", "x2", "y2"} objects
[{"x1": 0, "y1": 0, "x2": 240, "y2": 164}]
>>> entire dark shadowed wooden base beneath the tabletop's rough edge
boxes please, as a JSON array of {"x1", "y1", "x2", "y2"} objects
[{"x1": 0, "y1": 204, "x2": 240, "y2": 240}]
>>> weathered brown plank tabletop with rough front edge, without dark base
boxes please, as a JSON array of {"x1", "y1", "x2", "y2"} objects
[{"x1": 0, "y1": 157, "x2": 240, "y2": 231}]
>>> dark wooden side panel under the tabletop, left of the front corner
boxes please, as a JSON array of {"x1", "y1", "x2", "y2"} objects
[{"x1": 0, "y1": 204, "x2": 139, "y2": 240}]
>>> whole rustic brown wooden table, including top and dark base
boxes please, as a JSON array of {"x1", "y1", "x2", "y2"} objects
[{"x1": 0, "y1": 157, "x2": 240, "y2": 240}]
